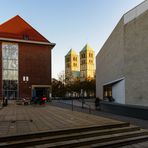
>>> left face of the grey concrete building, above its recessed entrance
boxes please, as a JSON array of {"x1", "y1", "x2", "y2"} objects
[{"x1": 96, "y1": 18, "x2": 124, "y2": 99}]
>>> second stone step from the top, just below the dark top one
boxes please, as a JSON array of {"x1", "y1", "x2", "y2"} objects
[{"x1": 0, "y1": 126, "x2": 143, "y2": 148}]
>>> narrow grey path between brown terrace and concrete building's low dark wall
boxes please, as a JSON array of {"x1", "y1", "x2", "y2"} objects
[{"x1": 52, "y1": 100, "x2": 148, "y2": 129}]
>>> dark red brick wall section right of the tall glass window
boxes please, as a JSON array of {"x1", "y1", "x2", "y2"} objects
[{"x1": 19, "y1": 43, "x2": 52, "y2": 97}]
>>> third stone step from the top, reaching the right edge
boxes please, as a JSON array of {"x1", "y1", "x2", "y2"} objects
[{"x1": 34, "y1": 130, "x2": 148, "y2": 148}]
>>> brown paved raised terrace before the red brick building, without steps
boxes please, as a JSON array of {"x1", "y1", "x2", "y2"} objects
[{"x1": 0, "y1": 102, "x2": 121, "y2": 136}]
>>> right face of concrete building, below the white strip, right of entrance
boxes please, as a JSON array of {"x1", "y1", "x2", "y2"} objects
[{"x1": 124, "y1": 11, "x2": 148, "y2": 106}]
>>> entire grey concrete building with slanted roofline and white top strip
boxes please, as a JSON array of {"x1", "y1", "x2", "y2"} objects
[{"x1": 96, "y1": 1, "x2": 148, "y2": 106}]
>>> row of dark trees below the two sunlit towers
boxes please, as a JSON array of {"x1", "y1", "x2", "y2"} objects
[{"x1": 52, "y1": 71, "x2": 96, "y2": 97}]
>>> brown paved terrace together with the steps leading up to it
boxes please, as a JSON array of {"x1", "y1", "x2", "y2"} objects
[{"x1": 0, "y1": 100, "x2": 148, "y2": 148}]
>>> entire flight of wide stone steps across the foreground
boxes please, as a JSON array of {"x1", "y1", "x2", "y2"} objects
[{"x1": 0, "y1": 123, "x2": 148, "y2": 148}]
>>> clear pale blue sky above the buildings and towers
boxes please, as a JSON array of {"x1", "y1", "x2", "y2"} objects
[{"x1": 0, "y1": 0, "x2": 144, "y2": 78}]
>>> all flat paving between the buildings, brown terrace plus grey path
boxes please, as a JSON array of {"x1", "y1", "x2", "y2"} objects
[{"x1": 0, "y1": 101, "x2": 148, "y2": 148}]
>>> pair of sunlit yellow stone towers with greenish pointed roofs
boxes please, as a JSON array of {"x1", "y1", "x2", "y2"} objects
[{"x1": 65, "y1": 44, "x2": 95, "y2": 81}]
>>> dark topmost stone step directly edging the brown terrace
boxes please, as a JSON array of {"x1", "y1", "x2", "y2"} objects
[{"x1": 0, "y1": 122, "x2": 130, "y2": 142}]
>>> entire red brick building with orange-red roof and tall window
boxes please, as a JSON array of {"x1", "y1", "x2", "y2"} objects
[{"x1": 0, "y1": 15, "x2": 55, "y2": 99}]
